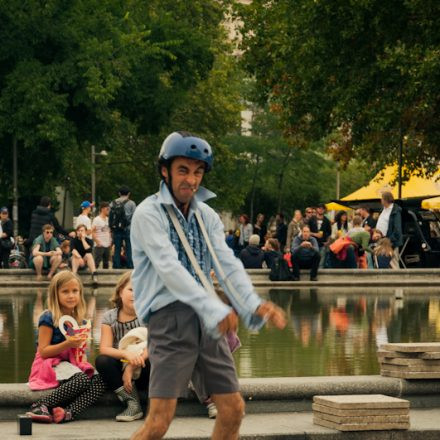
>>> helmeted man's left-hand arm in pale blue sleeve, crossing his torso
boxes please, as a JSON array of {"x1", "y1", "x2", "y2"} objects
[{"x1": 131, "y1": 207, "x2": 231, "y2": 334}]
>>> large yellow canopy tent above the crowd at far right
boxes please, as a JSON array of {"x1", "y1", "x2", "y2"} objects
[{"x1": 341, "y1": 165, "x2": 440, "y2": 201}]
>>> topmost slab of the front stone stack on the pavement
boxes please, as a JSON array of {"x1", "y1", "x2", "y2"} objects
[{"x1": 313, "y1": 394, "x2": 409, "y2": 409}]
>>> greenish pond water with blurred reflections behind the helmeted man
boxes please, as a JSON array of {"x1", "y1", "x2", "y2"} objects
[{"x1": 0, "y1": 289, "x2": 440, "y2": 382}]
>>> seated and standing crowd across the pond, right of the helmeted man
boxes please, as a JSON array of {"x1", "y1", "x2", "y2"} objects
[{"x1": 234, "y1": 192, "x2": 403, "y2": 281}]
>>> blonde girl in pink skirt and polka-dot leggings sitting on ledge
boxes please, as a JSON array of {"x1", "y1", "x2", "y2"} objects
[{"x1": 28, "y1": 271, "x2": 105, "y2": 423}]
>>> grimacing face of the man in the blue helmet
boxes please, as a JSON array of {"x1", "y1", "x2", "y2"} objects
[{"x1": 162, "y1": 157, "x2": 205, "y2": 204}]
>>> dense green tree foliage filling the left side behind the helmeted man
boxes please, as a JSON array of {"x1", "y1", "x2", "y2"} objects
[{"x1": 0, "y1": 0, "x2": 231, "y2": 217}]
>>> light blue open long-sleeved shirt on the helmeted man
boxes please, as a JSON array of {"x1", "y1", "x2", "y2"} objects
[{"x1": 131, "y1": 182, "x2": 263, "y2": 336}]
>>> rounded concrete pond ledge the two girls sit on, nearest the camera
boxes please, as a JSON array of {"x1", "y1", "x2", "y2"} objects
[{"x1": 0, "y1": 376, "x2": 440, "y2": 420}]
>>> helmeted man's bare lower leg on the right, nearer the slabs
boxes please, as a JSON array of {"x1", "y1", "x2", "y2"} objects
[{"x1": 212, "y1": 393, "x2": 244, "y2": 440}]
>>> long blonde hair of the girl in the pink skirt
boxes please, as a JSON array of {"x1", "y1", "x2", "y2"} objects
[{"x1": 47, "y1": 270, "x2": 86, "y2": 327}]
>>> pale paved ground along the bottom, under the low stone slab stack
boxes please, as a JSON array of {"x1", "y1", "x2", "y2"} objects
[{"x1": 0, "y1": 408, "x2": 440, "y2": 440}]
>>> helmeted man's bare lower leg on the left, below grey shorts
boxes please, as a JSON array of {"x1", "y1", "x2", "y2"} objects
[{"x1": 131, "y1": 398, "x2": 177, "y2": 440}]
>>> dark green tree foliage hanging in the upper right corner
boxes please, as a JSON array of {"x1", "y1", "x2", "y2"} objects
[{"x1": 236, "y1": 0, "x2": 440, "y2": 175}]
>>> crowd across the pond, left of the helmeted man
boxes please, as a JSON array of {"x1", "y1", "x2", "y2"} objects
[{"x1": 0, "y1": 186, "x2": 136, "y2": 282}]
